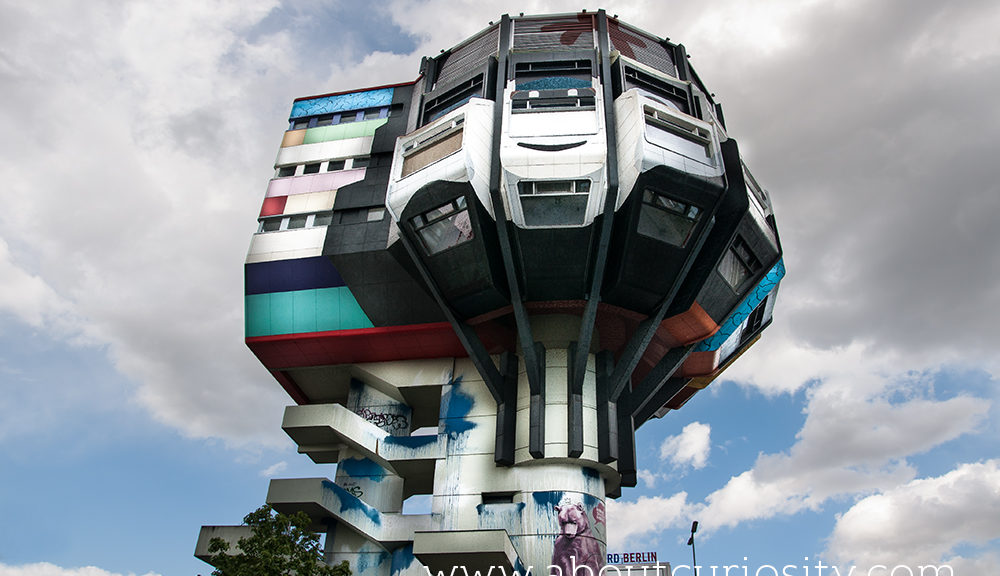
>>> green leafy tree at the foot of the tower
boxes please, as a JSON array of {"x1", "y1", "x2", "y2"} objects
[{"x1": 208, "y1": 504, "x2": 351, "y2": 576}]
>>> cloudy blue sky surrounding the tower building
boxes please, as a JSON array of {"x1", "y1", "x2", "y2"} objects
[{"x1": 0, "y1": 0, "x2": 1000, "y2": 576}]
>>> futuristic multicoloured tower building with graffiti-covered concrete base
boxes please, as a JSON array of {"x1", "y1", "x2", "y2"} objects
[{"x1": 196, "y1": 11, "x2": 784, "y2": 576}]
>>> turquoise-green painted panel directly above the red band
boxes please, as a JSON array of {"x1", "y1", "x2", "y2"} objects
[{"x1": 244, "y1": 286, "x2": 373, "y2": 337}]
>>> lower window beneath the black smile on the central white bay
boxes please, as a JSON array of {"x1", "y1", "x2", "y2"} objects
[{"x1": 517, "y1": 180, "x2": 590, "y2": 227}]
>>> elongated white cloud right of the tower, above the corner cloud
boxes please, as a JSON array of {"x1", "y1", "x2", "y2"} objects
[{"x1": 704, "y1": 354, "x2": 991, "y2": 526}]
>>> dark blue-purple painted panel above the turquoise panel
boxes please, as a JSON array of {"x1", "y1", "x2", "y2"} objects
[{"x1": 243, "y1": 256, "x2": 344, "y2": 295}]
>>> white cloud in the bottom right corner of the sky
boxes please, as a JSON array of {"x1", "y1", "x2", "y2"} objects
[{"x1": 828, "y1": 460, "x2": 1000, "y2": 574}]
